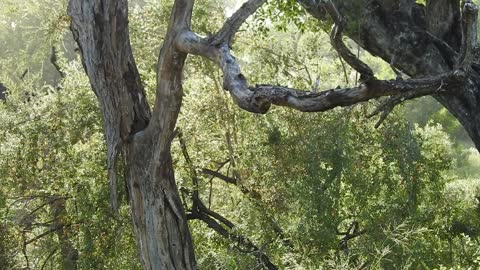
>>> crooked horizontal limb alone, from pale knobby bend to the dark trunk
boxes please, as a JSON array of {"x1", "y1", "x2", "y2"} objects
[{"x1": 176, "y1": 31, "x2": 464, "y2": 113}]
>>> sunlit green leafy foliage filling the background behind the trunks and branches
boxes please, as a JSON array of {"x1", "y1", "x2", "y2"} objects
[{"x1": 0, "y1": 0, "x2": 480, "y2": 269}]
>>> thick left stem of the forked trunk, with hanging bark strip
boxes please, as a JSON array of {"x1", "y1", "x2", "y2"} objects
[{"x1": 68, "y1": 0, "x2": 150, "y2": 213}]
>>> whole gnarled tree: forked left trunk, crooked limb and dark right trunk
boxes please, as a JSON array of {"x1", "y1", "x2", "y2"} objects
[{"x1": 68, "y1": 0, "x2": 480, "y2": 269}]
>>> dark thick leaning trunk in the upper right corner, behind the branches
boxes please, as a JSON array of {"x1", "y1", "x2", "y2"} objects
[{"x1": 297, "y1": 0, "x2": 480, "y2": 151}]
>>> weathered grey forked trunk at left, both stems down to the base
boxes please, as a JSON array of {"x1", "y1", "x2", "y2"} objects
[{"x1": 68, "y1": 0, "x2": 196, "y2": 269}]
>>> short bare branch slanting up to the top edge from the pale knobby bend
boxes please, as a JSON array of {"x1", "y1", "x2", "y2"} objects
[{"x1": 211, "y1": 0, "x2": 267, "y2": 45}]
